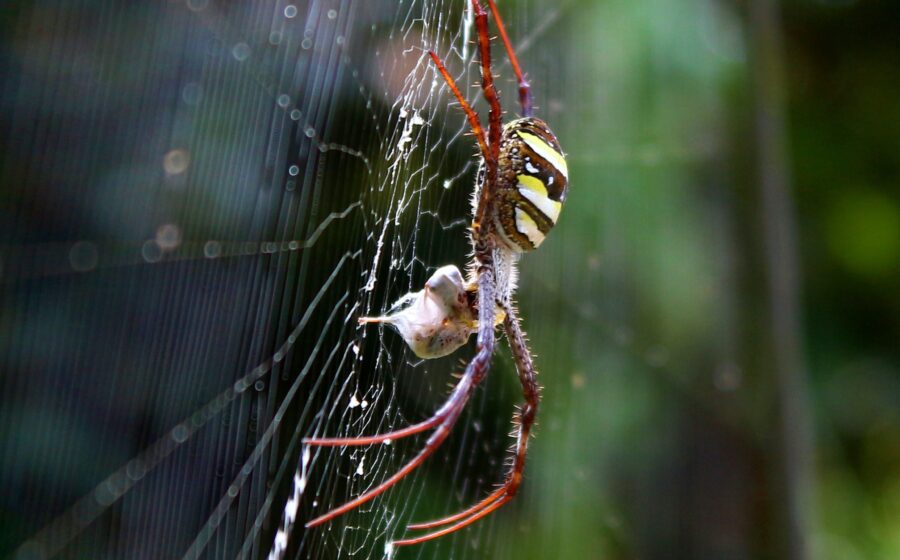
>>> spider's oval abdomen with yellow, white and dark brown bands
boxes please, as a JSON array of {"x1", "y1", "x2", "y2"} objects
[{"x1": 496, "y1": 118, "x2": 569, "y2": 252}]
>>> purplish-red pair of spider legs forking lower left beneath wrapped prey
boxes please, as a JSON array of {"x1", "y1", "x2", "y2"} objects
[{"x1": 306, "y1": 266, "x2": 496, "y2": 528}]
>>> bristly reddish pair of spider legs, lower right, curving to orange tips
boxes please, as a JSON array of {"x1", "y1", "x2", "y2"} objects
[{"x1": 393, "y1": 306, "x2": 541, "y2": 546}]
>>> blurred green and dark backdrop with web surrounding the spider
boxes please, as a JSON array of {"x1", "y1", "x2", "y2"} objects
[{"x1": 0, "y1": 0, "x2": 900, "y2": 560}]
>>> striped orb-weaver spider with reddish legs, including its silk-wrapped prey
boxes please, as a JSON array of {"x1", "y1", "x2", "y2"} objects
[{"x1": 304, "y1": 0, "x2": 568, "y2": 546}]
